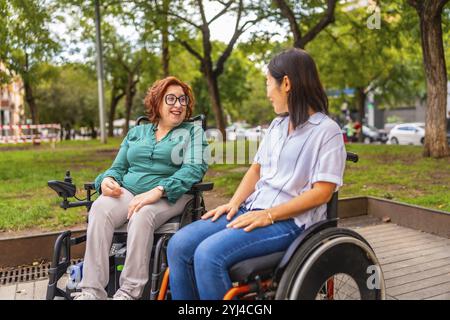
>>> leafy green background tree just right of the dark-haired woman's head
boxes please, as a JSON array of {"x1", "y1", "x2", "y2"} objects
[{"x1": 308, "y1": 2, "x2": 423, "y2": 138}]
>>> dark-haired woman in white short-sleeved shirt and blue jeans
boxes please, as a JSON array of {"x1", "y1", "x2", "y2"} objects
[{"x1": 167, "y1": 49, "x2": 346, "y2": 300}]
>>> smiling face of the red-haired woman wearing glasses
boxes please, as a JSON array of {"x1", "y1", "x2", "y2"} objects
[{"x1": 159, "y1": 85, "x2": 189, "y2": 127}]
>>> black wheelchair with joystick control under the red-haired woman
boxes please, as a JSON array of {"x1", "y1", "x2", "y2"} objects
[{"x1": 46, "y1": 115, "x2": 213, "y2": 300}]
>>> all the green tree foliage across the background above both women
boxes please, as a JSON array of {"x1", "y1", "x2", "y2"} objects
[{"x1": 0, "y1": 0, "x2": 442, "y2": 132}]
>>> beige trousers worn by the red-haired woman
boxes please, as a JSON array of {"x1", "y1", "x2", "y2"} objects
[{"x1": 79, "y1": 188, "x2": 193, "y2": 299}]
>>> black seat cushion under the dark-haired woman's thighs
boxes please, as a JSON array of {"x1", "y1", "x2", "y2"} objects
[{"x1": 229, "y1": 251, "x2": 285, "y2": 282}]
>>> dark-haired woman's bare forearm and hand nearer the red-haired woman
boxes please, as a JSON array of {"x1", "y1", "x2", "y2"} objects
[{"x1": 202, "y1": 163, "x2": 261, "y2": 221}]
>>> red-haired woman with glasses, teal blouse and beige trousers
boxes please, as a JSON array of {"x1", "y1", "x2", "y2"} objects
[{"x1": 75, "y1": 77, "x2": 208, "y2": 300}]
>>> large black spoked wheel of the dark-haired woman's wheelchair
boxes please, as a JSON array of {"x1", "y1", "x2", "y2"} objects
[{"x1": 275, "y1": 228, "x2": 385, "y2": 300}]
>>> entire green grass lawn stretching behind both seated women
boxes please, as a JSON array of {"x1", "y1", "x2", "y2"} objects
[{"x1": 0, "y1": 138, "x2": 450, "y2": 231}]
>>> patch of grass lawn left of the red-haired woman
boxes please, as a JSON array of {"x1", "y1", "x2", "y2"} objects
[{"x1": 0, "y1": 139, "x2": 120, "y2": 231}]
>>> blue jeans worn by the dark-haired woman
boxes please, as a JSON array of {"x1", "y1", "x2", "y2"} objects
[{"x1": 167, "y1": 207, "x2": 304, "y2": 300}]
